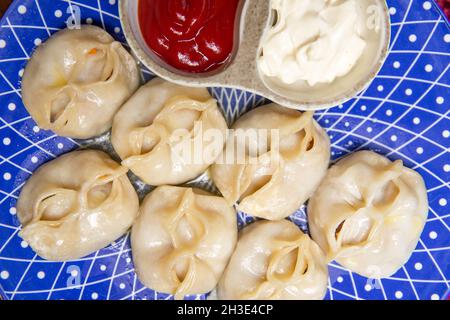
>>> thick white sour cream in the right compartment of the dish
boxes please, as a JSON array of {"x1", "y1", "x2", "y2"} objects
[{"x1": 258, "y1": 0, "x2": 379, "y2": 87}]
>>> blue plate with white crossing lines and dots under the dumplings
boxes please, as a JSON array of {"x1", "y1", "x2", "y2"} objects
[{"x1": 0, "y1": 0, "x2": 450, "y2": 299}]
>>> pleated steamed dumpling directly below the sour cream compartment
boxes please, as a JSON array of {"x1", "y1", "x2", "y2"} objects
[{"x1": 211, "y1": 104, "x2": 330, "y2": 220}]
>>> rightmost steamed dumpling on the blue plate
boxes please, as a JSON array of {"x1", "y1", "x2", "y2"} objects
[{"x1": 308, "y1": 151, "x2": 428, "y2": 279}]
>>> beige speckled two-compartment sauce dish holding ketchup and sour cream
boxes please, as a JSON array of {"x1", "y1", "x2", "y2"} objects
[{"x1": 119, "y1": 0, "x2": 391, "y2": 110}]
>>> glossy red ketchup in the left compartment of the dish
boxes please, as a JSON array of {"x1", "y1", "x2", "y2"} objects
[{"x1": 138, "y1": 0, "x2": 240, "y2": 73}]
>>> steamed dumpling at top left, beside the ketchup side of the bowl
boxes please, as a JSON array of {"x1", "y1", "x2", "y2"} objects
[{"x1": 22, "y1": 26, "x2": 140, "y2": 139}]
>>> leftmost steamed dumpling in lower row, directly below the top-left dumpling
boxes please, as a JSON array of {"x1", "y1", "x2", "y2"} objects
[{"x1": 17, "y1": 150, "x2": 139, "y2": 261}]
